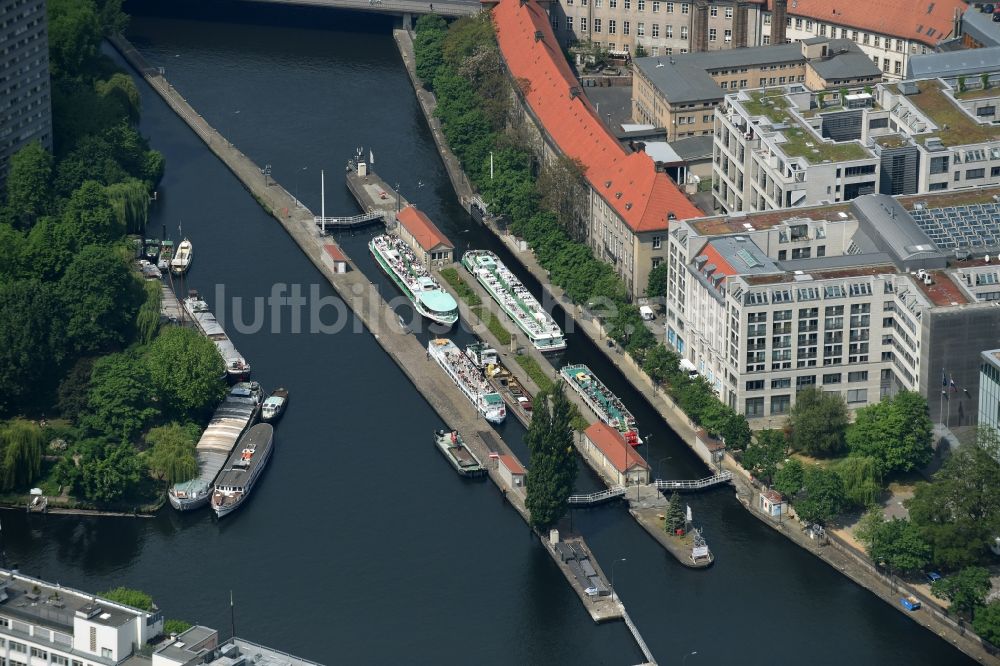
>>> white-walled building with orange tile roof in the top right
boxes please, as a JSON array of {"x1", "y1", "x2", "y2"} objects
[{"x1": 760, "y1": 0, "x2": 968, "y2": 79}]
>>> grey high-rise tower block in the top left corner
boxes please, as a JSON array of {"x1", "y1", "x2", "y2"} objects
[{"x1": 0, "y1": 0, "x2": 52, "y2": 186}]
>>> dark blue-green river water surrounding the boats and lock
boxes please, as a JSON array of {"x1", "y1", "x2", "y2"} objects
[{"x1": 3, "y1": 3, "x2": 968, "y2": 666}]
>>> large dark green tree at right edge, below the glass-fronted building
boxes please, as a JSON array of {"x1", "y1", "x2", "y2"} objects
[{"x1": 908, "y1": 444, "x2": 1000, "y2": 569}]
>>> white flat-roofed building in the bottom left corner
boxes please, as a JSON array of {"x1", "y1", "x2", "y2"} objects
[{"x1": 0, "y1": 570, "x2": 317, "y2": 666}]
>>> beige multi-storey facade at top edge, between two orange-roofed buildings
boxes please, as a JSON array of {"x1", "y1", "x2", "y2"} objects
[{"x1": 550, "y1": 0, "x2": 761, "y2": 56}]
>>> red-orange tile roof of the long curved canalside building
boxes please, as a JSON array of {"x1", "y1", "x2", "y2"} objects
[{"x1": 493, "y1": 0, "x2": 704, "y2": 231}]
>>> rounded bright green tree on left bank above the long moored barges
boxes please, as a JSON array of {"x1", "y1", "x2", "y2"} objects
[{"x1": 146, "y1": 326, "x2": 226, "y2": 413}]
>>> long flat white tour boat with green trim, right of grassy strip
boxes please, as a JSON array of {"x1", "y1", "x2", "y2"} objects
[{"x1": 462, "y1": 250, "x2": 566, "y2": 352}]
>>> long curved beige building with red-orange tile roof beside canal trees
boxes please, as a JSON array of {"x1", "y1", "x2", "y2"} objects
[{"x1": 493, "y1": 0, "x2": 703, "y2": 296}]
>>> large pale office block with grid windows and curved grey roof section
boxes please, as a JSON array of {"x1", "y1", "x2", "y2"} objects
[{"x1": 665, "y1": 189, "x2": 1000, "y2": 428}]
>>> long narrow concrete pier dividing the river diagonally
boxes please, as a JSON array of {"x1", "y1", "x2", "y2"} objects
[{"x1": 110, "y1": 37, "x2": 623, "y2": 622}]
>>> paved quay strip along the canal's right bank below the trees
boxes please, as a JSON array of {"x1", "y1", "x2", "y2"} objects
[{"x1": 394, "y1": 20, "x2": 1000, "y2": 663}]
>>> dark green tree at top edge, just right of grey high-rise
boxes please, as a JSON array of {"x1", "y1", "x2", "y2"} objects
[{"x1": 48, "y1": 0, "x2": 102, "y2": 78}]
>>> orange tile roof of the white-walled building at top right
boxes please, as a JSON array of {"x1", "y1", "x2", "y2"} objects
[{"x1": 768, "y1": 0, "x2": 968, "y2": 46}]
